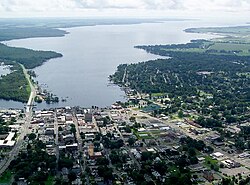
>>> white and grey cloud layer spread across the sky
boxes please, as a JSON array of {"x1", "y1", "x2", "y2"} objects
[{"x1": 0, "y1": 0, "x2": 250, "y2": 16}]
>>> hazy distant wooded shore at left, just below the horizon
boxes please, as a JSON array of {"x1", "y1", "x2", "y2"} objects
[{"x1": 0, "y1": 18, "x2": 164, "y2": 41}]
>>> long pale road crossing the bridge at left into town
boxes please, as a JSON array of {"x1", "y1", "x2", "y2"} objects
[{"x1": 0, "y1": 65, "x2": 36, "y2": 175}]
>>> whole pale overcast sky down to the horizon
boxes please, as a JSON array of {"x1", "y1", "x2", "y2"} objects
[{"x1": 0, "y1": 0, "x2": 250, "y2": 19}]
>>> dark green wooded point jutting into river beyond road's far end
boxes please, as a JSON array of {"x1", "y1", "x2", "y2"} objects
[{"x1": 0, "y1": 44, "x2": 62, "y2": 69}]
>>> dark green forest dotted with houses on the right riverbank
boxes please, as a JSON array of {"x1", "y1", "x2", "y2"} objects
[{"x1": 110, "y1": 41, "x2": 250, "y2": 127}]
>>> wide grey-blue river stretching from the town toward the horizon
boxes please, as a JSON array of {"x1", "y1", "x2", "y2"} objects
[{"x1": 0, "y1": 21, "x2": 234, "y2": 108}]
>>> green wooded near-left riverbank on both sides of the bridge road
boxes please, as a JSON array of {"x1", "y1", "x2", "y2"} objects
[{"x1": 0, "y1": 41, "x2": 62, "y2": 102}]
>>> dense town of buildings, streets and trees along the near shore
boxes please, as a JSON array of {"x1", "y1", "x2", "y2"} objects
[{"x1": 0, "y1": 97, "x2": 250, "y2": 185}]
